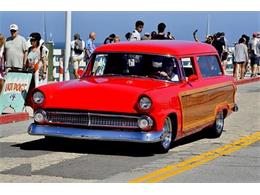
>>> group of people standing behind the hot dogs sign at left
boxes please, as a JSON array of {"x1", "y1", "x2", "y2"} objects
[{"x1": 0, "y1": 24, "x2": 49, "y2": 89}]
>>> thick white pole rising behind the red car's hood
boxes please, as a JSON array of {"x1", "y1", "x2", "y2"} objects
[{"x1": 63, "y1": 11, "x2": 71, "y2": 81}]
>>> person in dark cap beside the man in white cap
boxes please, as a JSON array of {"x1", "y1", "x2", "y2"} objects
[{"x1": 26, "y1": 32, "x2": 48, "y2": 87}]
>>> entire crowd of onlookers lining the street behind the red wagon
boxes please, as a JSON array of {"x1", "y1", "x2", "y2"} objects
[{"x1": 0, "y1": 20, "x2": 260, "y2": 91}]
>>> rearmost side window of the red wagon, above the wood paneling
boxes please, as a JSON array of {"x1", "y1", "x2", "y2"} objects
[{"x1": 197, "y1": 56, "x2": 222, "y2": 77}]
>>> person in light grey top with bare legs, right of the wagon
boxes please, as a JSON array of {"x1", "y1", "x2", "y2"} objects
[{"x1": 233, "y1": 37, "x2": 248, "y2": 80}]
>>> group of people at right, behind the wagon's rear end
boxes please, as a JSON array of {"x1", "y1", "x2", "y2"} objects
[{"x1": 193, "y1": 30, "x2": 260, "y2": 80}]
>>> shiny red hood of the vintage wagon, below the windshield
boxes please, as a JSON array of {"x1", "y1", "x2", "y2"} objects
[{"x1": 38, "y1": 77, "x2": 170, "y2": 113}]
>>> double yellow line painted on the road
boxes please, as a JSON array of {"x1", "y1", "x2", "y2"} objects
[{"x1": 129, "y1": 132, "x2": 260, "y2": 183}]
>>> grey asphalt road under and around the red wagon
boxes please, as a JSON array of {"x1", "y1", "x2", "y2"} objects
[{"x1": 0, "y1": 82, "x2": 260, "y2": 183}]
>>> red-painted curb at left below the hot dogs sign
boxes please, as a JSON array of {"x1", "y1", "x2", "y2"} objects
[{"x1": 0, "y1": 112, "x2": 29, "y2": 124}]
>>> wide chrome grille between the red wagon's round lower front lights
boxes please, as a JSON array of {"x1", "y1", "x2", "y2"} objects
[{"x1": 46, "y1": 111, "x2": 139, "y2": 129}]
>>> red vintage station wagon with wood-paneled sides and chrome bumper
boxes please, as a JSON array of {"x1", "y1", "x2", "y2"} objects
[{"x1": 28, "y1": 40, "x2": 238, "y2": 152}]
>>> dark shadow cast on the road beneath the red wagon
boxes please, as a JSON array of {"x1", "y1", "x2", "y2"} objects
[{"x1": 13, "y1": 128, "x2": 223, "y2": 157}]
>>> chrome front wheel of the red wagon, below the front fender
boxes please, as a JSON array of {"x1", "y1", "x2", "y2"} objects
[{"x1": 157, "y1": 117, "x2": 173, "y2": 153}]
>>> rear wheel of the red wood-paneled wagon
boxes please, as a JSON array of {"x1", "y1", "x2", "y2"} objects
[{"x1": 209, "y1": 111, "x2": 224, "y2": 138}]
